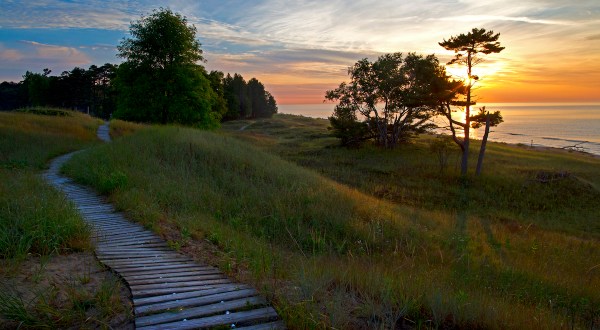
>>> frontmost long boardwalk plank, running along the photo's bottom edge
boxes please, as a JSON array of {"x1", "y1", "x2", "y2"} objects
[{"x1": 137, "y1": 307, "x2": 277, "y2": 330}]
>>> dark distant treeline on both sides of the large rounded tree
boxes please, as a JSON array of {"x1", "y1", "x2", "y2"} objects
[{"x1": 0, "y1": 63, "x2": 277, "y2": 121}]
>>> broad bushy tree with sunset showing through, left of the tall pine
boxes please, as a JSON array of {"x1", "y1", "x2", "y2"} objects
[{"x1": 325, "y1": 53, "x2": 444, "y2": 148}]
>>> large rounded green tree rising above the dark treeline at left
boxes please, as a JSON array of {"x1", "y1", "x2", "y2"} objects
[{"x1": 114, "y1": 8, "x2": 221, "y2": 127}]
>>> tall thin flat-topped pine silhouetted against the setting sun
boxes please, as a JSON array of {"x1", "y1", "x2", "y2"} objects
[{"x1": 439, "y1": 28, "x2": 504, "y2": 176}]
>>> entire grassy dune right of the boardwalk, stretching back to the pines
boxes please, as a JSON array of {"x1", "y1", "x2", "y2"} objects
[{"x1": 66, "y1": 116, "x2": 600, "y2": 328}]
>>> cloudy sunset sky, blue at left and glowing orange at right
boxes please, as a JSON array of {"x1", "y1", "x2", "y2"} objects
[{"x1": 0, "y1": 0, "x2": 600, "y2": 104}]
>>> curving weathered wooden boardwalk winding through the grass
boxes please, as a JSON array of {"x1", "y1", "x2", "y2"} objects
[{"x1": 44, "y1": 123, "x2": 285, "y2": 329}]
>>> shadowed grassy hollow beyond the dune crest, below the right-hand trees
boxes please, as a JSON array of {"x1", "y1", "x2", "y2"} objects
[{"x1": 223, "y1": 115, "x2": 600, "y2": 238}]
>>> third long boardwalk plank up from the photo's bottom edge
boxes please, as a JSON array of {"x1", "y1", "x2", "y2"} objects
[{"x1": 134, "y1": 289, "x2": 256, "y2": 315}]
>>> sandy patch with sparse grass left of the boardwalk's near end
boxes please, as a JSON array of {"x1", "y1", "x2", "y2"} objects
[{"x1": 0, "y1": 252, "x2": 134, "y2": 329}]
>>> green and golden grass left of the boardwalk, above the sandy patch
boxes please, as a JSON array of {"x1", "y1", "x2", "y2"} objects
[{"x1": 0, "y1": 109, "x2": 100, "y2": 259}]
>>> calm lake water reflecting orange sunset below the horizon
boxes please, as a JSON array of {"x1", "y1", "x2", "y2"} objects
[{"x1": 279, "y1": 103, "x2": 600, "y2": 155}]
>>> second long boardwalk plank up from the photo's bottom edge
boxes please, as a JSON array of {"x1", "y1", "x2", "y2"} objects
[{"x1": 135, "y1": 297, "x2": 265, "y2": 327}]
